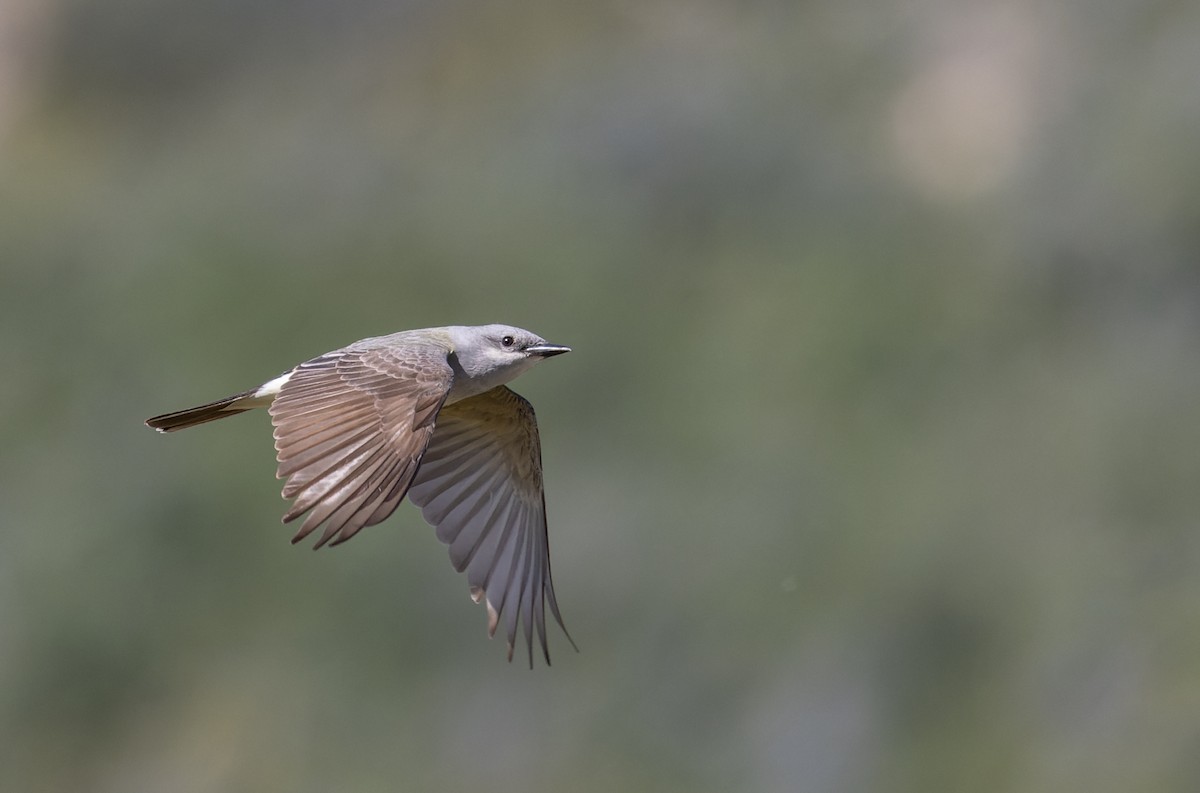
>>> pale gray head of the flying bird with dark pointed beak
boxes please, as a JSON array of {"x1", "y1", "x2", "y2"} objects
[{"x1": 446, "y1": 325, "x2": 571, "y2": 394}]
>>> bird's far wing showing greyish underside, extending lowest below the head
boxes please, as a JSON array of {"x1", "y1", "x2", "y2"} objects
[{"x1": 408, "y1": 386, "x2": 575, "y2": 666}]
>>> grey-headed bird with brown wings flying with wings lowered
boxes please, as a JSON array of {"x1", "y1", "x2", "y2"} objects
[{"x1": 145, "y1": 325, "x2": 578, "y2": 668}]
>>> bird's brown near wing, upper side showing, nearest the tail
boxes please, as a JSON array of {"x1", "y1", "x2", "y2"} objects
[{"x1": 270, "y1": 340, "x2": 454, "y2": 548}]
